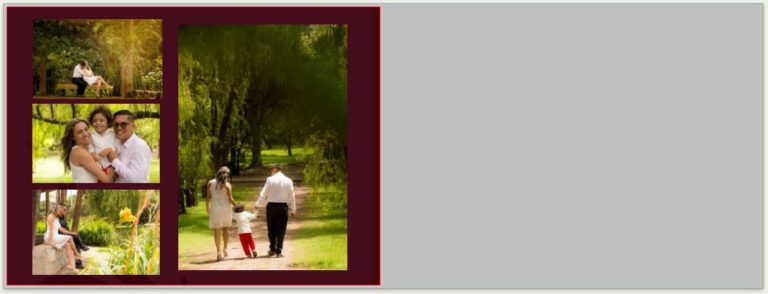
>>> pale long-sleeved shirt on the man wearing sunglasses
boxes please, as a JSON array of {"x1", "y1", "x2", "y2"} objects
[{"x1": 112, "y1": 134, "x2": 152, "y2": 183}]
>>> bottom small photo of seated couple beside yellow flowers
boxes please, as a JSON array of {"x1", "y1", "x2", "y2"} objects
[{"x1": 32, "y1": 189, "x2": 160, "y2": 275}]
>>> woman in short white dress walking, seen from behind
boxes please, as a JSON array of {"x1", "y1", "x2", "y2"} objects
[{"x1": 205, "y1": 166, "x2": 237, "y2": 261}]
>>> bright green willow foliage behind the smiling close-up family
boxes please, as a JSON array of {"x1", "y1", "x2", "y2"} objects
[{"x1": 32, "y1": 104, "x2": 160, "y2": 172}]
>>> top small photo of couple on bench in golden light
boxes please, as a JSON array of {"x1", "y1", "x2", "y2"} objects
[{"x1": 32, "y1": 19, "x2": 163, "y2": 99}]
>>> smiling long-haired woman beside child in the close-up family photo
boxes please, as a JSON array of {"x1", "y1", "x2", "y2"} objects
[{"x1": 59, "y1": 118, "x2": 115, "y2": 183}]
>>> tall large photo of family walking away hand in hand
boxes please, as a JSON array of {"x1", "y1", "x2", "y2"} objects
[{"x1": 178, "y1": 25, "x2": 348, "y2": 270}]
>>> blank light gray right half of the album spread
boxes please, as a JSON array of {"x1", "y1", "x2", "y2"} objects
[{"x1": 382, "y1": 4, "x2": 763, "y2": 288}]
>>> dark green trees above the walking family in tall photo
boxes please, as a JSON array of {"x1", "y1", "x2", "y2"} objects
[{"x1": 178, "y1": 25, "x2": 347, "y2": 212}]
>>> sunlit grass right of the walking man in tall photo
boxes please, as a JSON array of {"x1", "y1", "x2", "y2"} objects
[{"x1": 293, "y1": 193, "x2": 347, "y2": 270}]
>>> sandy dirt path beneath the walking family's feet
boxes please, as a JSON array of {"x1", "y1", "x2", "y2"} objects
[{"x1": 179, "y1": 183, "x2": 309, "y2": 270}]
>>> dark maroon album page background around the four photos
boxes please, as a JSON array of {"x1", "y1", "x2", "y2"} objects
[{"x1": 5, "y1": 6, "x2": 381, "y2": 286}]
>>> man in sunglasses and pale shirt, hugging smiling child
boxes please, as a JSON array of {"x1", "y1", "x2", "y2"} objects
[{"x1": 108, "y1": 110, "x2": 152, "y2": 183}]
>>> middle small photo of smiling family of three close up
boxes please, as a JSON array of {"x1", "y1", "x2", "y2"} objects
[{"x1": 32, "y1": 104, "x2": 160, "y2": 183}]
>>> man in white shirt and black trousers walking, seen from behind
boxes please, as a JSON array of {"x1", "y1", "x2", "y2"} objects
[{"x1": 256, "y1": 164, "x2": 296, "y2": 257}]
